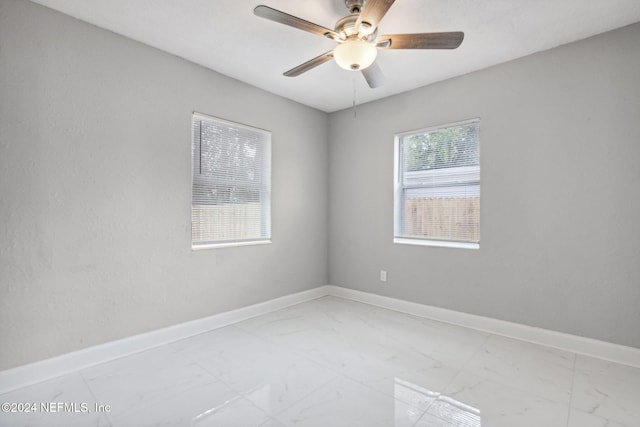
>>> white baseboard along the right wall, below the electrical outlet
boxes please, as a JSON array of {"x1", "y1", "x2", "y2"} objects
[{"x1": 326, "y1": 286, "x2": 640, "y2": 367}]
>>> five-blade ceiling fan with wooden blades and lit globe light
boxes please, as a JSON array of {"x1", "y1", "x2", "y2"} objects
[{"x1": 253, "y1": 0, "x2": 464, "y2": 88}]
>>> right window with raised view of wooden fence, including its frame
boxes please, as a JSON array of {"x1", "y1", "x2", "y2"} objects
[{"x1": 394, "y1": 120, "x2": 480, "y2": 248}]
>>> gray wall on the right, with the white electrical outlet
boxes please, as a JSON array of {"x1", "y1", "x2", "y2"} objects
[{"x1": 329, "y1": 24, "x2": 640, "y2": 347}]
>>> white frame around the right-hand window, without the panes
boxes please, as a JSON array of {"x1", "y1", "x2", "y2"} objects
[{"x1": 393, "y1": 117, "x2": 482, "y2": 250}]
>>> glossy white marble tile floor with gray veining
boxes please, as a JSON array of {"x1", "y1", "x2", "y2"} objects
[{"x1": 0, "y1": 297, "x2": 640, "y2": 427}]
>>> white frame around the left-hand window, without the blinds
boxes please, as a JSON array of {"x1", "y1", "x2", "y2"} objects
[{"x1": 190, "y1": 111, "x2": 272, "y2": 251}]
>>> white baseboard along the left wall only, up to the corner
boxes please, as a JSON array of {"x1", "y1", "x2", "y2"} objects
[{"x1": 0, "y1": 286, "x2": 327, "y2": 394}]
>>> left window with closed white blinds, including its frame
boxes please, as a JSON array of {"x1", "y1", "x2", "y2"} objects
[{"x1": 191, "y1": 113, "x2": 271, "y2": 249}]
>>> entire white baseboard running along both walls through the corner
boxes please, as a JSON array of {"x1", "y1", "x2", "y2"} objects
[{"x1": 0, "y1": 285, "x2": 640, "y2": 394}]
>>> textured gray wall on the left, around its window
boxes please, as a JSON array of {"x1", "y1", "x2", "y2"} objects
[{"x1": 0, "y1": 0, "x2": 328, "y2": 370}]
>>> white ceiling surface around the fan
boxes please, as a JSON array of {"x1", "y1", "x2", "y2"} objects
[{"x1": 33, "y1": 0, "x2": 640, "y2": 112}]
